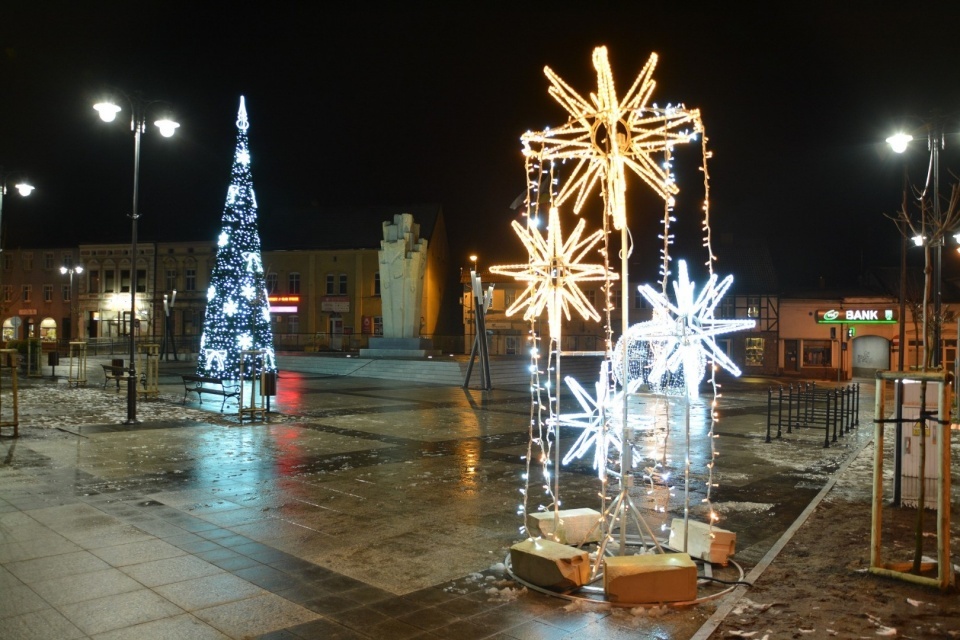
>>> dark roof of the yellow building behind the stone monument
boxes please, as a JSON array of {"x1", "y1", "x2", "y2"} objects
[{"x1": 260, "y1": 204, "x2": 443, "y2": 251}]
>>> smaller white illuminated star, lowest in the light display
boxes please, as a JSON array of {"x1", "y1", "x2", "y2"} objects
[{"x1": 557, "y1": 361, "x2": 640, "y2": 472}]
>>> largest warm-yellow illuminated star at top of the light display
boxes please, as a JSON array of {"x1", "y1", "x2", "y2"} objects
[{"x1": 521, "y1": 47, "x2": 702, "y2": 230}]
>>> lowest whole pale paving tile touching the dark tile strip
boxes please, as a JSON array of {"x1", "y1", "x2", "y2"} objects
[{"x1": 193, "y1": 593, "x2": 320, "y2": 638}]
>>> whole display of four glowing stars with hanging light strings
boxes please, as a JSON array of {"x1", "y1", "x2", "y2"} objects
[{"x1": 495, "y1": 47, "x2": 753, "y2": 560}]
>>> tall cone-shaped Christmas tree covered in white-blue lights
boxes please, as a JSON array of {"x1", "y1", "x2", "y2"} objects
[{"x1": 197, "y1": 96, "x2": 276, "y2": 379}]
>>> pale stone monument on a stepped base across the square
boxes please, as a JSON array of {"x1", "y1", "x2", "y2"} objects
[{"x1": 360, "y1": 213, "x2": 439, "y2": 357}]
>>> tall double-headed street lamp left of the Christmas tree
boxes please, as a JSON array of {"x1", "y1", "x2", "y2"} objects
[{"x1": 93, "y1": 93, "x2": 180, "y2": 424}]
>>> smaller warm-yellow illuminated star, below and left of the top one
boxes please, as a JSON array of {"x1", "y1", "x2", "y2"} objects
[{"x1": 490, "y1": 207, "x2": 616, "y2": 340}]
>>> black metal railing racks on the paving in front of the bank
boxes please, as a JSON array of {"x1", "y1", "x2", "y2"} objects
[{"x1": 766, "y1": 382, "x2": 860, "y2": 447}]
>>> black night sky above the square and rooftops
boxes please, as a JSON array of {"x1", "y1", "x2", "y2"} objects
[{"x1": 0, "y1": 0, "x2": 960, "y2": 287}]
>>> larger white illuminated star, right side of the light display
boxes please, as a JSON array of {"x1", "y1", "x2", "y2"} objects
[{"x1": 614, "y1": 260, "x2": 755, "y2": 399}]
